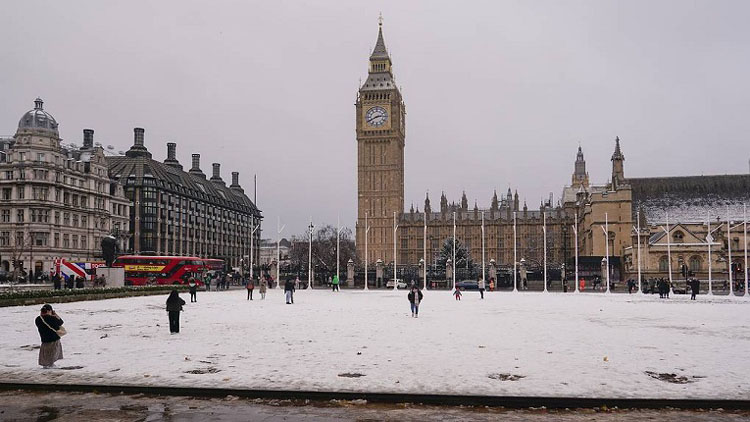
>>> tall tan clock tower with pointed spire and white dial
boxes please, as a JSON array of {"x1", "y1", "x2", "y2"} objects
[{"x1": 355, "y1": 19, "x2": 406, "y2": 264}]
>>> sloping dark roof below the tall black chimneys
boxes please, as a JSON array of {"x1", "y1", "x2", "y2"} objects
[{"x1": 107, "y1": 156, "x2": 262, "y2": 218}]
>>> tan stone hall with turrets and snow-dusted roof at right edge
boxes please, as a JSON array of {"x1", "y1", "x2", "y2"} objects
[{"x1": 563, "y1": 138, "x2": 750, "y2": 281}]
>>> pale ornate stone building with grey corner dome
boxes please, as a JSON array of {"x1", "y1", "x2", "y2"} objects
[{"x1": 0, "y1": 98, "x2": 130, "y2": 276}]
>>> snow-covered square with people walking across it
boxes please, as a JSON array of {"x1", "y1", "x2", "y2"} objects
[{"x1": 0, "y1": 290, "x2": 750, "y2": 399}]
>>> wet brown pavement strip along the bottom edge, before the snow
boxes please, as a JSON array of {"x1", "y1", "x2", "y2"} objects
[{"x1": 0, "y1": 391, "x2": 750, "y2": 422}]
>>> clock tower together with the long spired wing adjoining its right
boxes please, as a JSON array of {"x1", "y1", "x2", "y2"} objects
[{"x1": 355, "y1": 24, "x2": 572, "y2": 274}]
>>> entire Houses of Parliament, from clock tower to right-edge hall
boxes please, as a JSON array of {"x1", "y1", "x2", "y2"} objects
[{"x1": 355, "y1": 22, "x2": 750, "y2": 277}]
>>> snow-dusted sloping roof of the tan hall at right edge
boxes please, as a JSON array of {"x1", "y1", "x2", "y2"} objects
[{"x1": 627, "y1": 174, "x2": 750, "y2": 224}]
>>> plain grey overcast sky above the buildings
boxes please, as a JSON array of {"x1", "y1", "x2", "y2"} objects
[{"x1": 0, "y1": 0, "x2": 750, "y2": 237}]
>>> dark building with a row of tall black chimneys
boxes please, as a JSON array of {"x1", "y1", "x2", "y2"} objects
[{"x1": 107, "y1": 128, "x2": 263, "y2": 267}]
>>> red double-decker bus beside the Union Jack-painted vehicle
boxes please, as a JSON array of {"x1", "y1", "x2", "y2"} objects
[{"x1": 112, "y1": 255, "x2": 223, "y2": 286}]
